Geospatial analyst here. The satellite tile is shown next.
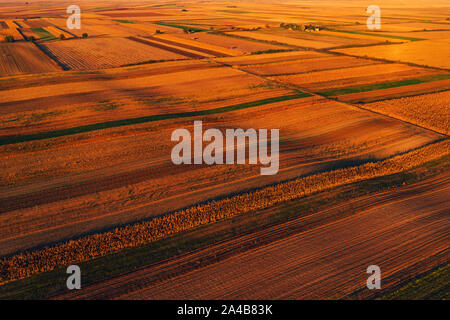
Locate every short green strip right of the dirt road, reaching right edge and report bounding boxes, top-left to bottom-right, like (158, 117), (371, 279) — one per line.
(318, 74), (450, 97)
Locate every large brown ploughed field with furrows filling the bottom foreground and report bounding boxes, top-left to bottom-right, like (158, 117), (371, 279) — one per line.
(57, 174), (450, 300)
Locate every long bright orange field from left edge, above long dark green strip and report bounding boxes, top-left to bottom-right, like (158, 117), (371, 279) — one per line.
(0, 64), (268, 113)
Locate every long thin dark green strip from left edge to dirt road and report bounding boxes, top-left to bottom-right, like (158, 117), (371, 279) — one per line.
(0, 93), (311, 146)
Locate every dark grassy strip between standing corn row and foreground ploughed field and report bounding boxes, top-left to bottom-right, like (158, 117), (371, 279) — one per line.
(0, 156), (450, 299)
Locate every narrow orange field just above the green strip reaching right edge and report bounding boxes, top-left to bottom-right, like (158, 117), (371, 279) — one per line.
(242, 56), (377, 76)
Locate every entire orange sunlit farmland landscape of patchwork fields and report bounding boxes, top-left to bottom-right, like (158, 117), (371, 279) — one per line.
(0, 0), (450, 300)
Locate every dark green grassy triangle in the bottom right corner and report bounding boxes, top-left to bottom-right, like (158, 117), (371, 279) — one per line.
(380, 264), (450, 300)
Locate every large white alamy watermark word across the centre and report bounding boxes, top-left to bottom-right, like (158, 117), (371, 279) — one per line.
(171, 121), (280, 175)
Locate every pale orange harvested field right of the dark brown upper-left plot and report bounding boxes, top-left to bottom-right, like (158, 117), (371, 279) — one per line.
(42, 38), (184, 70)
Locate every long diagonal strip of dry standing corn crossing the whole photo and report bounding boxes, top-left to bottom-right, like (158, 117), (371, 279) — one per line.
(0, 140), (450, 283)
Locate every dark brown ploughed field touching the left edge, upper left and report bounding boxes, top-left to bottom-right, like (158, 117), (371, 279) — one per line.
(0, 43), (61, 77)
